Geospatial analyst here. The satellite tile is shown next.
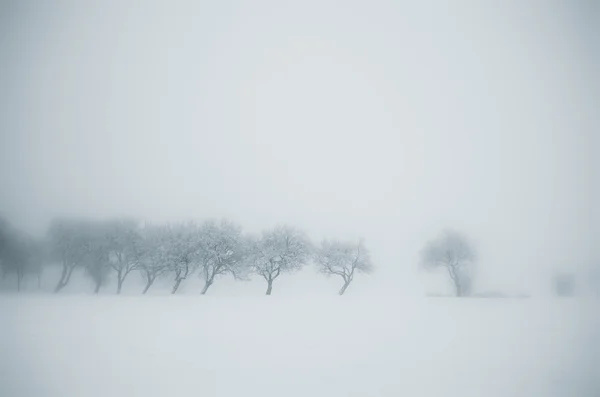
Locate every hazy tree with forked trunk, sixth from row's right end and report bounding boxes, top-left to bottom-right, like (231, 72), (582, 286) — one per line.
(107, 218), (141, 294)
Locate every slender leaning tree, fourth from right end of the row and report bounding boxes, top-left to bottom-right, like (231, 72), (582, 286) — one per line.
(167, 222), (201, 294)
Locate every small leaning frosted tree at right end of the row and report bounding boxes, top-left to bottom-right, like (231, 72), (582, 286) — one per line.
(315, 239), (373, 295)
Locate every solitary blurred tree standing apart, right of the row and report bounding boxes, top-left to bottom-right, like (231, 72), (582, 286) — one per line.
(421, 230), (476, 297)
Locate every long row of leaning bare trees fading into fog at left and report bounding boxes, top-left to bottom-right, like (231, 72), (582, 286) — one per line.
(0, 218), (373, 295)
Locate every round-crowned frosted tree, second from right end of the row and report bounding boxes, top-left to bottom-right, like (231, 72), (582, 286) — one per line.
(249, 226), (312, 295)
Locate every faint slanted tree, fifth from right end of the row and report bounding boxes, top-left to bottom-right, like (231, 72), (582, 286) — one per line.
(137, 225), (169, 294)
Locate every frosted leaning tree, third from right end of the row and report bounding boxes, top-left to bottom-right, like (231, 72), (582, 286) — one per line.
(198, 220), (248, 295)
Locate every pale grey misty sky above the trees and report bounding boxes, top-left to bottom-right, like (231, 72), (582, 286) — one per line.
(0, 0), (600, 290)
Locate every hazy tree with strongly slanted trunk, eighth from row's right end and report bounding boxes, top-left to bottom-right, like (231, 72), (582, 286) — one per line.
(48, 218), (87, 293)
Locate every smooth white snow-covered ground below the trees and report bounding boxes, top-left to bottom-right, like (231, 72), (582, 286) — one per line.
(0, 295), (600, 397)
